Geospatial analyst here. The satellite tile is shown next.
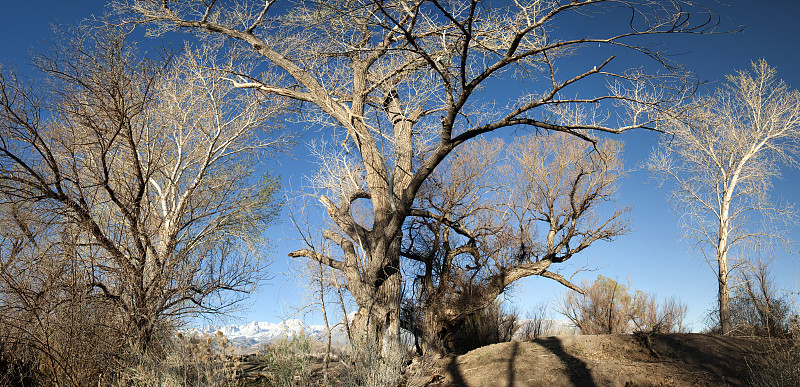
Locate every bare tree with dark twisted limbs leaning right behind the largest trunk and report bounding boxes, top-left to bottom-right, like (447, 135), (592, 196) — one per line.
(401, 133), (628, 350)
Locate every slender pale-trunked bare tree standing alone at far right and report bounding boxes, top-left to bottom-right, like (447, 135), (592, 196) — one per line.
(648, 60), (800, 334)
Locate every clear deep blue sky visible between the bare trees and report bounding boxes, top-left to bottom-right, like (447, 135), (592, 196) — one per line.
(0, 0), (800, 329)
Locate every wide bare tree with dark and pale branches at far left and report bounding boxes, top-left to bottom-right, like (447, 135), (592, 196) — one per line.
(0, 28), (287, 350)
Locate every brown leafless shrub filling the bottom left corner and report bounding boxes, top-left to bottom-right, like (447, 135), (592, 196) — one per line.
(0, 292), (124, 386)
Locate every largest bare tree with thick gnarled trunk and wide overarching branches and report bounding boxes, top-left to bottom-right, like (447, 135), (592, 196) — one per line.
(114, 0), (715, 354)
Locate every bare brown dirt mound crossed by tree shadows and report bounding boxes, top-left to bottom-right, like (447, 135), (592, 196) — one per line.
(424, 333), (765, 387)
